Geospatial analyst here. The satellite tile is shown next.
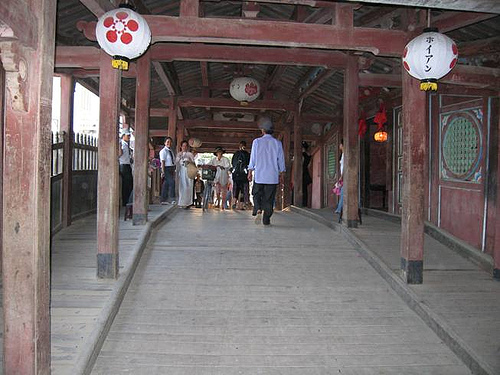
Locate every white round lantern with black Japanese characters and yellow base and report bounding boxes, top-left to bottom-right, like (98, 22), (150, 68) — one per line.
(403, 28), (458, 91)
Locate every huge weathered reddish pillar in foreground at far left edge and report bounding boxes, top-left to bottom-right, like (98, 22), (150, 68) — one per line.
(0, 0), (56, 375)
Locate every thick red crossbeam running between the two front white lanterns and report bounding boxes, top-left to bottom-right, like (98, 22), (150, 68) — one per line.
(77, 15), (408, 56)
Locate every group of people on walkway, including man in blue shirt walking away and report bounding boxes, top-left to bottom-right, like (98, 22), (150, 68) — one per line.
(160, 117), (285, 225)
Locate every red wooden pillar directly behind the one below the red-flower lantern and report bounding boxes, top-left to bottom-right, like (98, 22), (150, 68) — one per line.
(132, 52), (151, 225)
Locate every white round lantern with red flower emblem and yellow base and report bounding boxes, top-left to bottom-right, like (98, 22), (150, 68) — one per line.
(96, 7), (151, 70)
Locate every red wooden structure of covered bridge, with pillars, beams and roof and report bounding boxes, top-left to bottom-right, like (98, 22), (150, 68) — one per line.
(0, 0), (500, 374)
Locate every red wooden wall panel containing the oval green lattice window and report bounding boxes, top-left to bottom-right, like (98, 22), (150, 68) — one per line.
(429, 95), (489, 249)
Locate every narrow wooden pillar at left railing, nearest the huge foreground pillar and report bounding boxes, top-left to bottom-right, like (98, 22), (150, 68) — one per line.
(61, 75), (75, 227)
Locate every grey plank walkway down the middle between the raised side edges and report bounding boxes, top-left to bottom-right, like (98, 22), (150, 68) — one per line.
(93, 209), (470, 375)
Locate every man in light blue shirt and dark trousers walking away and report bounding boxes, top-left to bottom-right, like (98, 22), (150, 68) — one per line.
(248, 117), (285, 225)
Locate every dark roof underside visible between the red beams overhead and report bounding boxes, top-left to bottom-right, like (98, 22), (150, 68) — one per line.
(56, 0), (500, 151)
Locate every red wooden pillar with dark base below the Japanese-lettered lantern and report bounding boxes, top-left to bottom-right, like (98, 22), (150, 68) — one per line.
(401, 71), (429, 284)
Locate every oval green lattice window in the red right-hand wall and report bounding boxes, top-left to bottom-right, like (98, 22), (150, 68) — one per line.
(441, 114), (481, 180)
